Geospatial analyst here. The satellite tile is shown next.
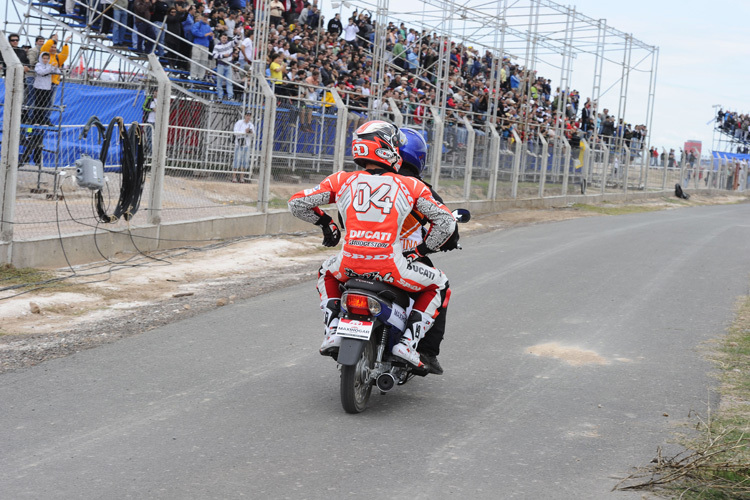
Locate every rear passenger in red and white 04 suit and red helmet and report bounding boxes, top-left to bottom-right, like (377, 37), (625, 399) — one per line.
(289, 120), (456, 368)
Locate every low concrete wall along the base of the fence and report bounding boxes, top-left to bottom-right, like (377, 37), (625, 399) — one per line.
(0, 191), (716, 269)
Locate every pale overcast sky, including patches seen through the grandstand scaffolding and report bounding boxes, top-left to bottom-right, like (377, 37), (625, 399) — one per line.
(323, 0), (750, 154)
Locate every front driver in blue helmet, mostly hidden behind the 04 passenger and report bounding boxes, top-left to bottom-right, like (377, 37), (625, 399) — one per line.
(398, 128), (458, 375)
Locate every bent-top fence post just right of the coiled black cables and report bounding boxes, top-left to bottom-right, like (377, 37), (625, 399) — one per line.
(148, 53), (172, 225)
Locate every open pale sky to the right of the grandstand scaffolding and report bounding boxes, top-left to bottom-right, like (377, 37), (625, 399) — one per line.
(571, 0), (750, 154)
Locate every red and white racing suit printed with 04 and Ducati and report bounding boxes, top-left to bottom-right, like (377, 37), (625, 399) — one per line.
(289, 169), (456, 318)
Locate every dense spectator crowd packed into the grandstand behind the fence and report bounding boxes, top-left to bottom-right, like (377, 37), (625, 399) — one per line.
(2, 0), (652, 158)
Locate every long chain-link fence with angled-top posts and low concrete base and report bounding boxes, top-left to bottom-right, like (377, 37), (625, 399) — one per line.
(0, 39), (748, 262)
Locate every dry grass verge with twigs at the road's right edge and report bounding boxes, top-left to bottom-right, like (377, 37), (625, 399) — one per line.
(617, 297), (750, 500)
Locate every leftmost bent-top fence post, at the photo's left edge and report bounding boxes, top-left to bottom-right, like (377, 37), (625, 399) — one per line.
(0, 34), (23, 249)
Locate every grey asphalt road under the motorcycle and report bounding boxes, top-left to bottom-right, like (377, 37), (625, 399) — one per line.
(0, 204), (750, 499)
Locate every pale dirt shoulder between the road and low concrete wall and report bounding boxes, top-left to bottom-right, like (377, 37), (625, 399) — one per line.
(0, 191), (748, 373)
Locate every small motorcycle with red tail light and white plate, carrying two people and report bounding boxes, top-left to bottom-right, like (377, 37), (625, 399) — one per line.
(335, 209), (471, 414)
